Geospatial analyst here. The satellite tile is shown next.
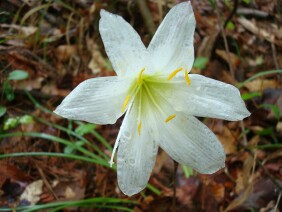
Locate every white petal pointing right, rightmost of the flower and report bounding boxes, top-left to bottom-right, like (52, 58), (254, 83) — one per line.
(151, 74), (250, 121)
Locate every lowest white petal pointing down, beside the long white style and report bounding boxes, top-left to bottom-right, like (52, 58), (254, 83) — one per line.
(117, 93), (158, 196)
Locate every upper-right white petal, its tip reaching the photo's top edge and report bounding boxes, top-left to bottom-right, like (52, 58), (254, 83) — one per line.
(148, 2), (196, 73)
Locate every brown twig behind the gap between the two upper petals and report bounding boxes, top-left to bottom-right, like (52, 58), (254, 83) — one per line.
(136, 0), (156, 36)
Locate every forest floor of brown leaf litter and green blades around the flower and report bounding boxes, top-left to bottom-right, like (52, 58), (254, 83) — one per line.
(0, 0), (282, 212)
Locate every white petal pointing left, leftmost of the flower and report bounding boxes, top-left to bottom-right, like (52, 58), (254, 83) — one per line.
(54, 77), (131, 124)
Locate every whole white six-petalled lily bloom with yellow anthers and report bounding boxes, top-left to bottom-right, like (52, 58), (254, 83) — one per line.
(55, 2), (250, 195)
